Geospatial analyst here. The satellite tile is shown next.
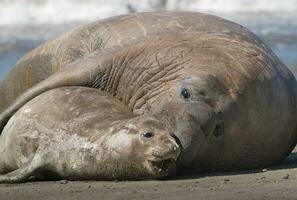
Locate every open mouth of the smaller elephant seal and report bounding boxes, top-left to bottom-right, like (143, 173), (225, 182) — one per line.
(148, 158), (176, 176)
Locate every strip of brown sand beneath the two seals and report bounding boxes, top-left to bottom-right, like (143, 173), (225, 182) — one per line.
(0, 149), (297, 200)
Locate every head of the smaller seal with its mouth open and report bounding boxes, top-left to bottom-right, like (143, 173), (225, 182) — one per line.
(104, 116), (180, 180)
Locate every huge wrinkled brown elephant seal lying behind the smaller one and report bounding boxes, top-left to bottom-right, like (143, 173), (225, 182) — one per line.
(0, 12), (297, 172)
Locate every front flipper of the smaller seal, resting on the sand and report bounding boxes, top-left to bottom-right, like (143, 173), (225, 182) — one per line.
(0, 154), (45, 183)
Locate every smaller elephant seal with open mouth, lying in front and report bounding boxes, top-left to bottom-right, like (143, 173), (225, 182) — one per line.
(0, 87), (180, 183)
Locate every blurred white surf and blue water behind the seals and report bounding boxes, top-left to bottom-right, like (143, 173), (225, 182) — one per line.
(0, 0), (297, 80)
